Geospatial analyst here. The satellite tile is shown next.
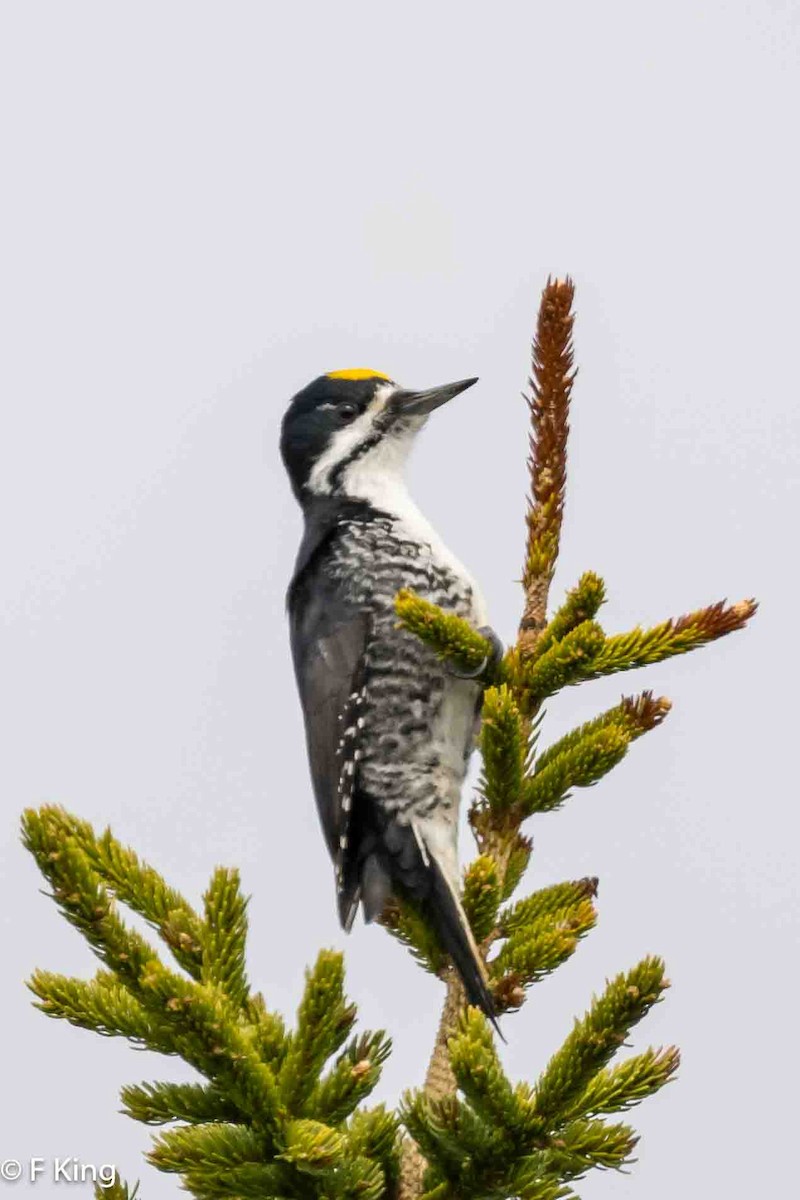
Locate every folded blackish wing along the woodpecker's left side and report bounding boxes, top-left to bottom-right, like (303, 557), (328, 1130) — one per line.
(289, 556), (368, 863)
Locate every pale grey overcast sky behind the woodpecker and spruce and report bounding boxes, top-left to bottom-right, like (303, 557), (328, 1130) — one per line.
(0, 0), (800, 1200)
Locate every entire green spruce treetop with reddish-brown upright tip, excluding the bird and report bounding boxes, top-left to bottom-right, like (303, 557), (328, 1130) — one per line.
(23, 280), (756, 1200)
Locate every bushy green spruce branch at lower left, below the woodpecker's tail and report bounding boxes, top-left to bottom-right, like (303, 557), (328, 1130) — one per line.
(24, 809), (399, 1200)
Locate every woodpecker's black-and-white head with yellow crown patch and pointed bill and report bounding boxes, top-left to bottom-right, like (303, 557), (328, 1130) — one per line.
(281, 367), (477, 503)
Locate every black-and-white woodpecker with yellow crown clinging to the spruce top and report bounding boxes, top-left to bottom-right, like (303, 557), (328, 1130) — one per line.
(281, 368), (495, 1019)
